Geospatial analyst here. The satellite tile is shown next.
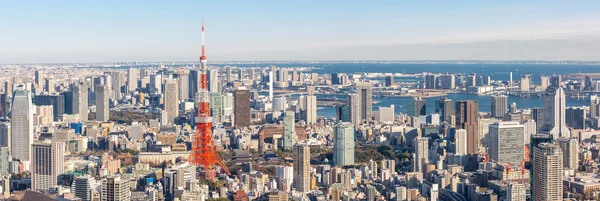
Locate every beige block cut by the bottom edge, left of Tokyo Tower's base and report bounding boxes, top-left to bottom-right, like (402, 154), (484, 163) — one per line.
(101, 177), (131, 201)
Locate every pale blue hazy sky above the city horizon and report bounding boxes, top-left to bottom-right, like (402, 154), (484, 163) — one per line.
(0, 0), (600, 63)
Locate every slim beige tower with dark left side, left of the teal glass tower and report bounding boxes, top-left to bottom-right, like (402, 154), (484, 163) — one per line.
(293, 144), (310, 193)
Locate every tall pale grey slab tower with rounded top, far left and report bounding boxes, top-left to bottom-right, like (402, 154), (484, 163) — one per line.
(10, 89), (34, 161)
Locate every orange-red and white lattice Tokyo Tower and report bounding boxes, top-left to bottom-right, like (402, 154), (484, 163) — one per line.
(188, 20), (231, 180)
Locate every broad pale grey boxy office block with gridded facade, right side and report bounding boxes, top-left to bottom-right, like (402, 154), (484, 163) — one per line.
(488, 121), (525, 166)
